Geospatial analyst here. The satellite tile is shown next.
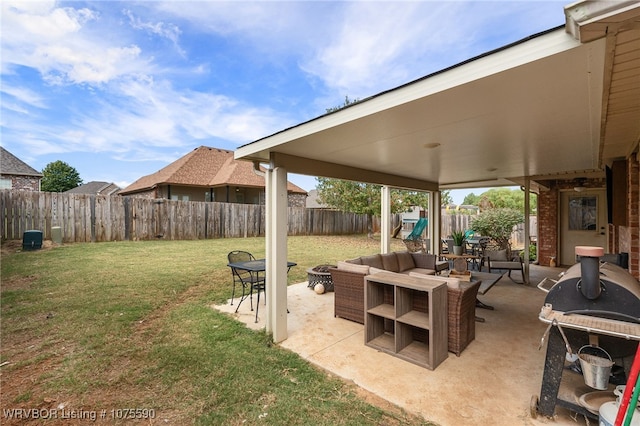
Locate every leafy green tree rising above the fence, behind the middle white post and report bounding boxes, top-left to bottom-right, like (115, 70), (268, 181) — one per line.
(316, 178), (429, 237)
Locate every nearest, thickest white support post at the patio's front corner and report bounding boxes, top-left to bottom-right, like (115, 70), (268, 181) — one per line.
(265, 167), (288, 343)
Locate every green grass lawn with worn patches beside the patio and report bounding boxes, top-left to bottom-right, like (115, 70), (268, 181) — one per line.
(0, 236), (426, 425)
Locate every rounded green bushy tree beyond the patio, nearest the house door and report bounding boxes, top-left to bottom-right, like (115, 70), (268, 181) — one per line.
(470, 208), (524, 256)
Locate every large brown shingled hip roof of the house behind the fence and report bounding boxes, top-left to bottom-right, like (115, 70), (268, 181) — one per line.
(120, 146), (307, 195)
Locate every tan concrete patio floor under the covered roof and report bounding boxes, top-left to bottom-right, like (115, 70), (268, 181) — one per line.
(215, 265), (597, 425)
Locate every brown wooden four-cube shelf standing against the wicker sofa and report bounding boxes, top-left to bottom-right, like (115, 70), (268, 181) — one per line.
(365, 272), (448, 370)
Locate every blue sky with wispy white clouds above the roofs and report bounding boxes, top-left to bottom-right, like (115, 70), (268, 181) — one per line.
(0, 0), (570, 203)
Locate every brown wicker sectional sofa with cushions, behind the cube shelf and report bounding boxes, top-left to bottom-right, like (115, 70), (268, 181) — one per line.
(329, 252), (480, 356)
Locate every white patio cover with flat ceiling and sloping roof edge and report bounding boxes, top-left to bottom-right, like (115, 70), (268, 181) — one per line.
(235, 2), (640, 190)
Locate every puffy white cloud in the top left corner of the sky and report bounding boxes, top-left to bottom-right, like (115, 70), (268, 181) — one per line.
(2, 2), (148, 84)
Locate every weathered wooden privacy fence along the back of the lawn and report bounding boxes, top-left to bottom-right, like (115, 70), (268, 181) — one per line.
(0, 190), (382, 242)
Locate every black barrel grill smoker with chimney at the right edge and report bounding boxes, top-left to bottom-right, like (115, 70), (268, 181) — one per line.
(531, 247), (640, 419)
